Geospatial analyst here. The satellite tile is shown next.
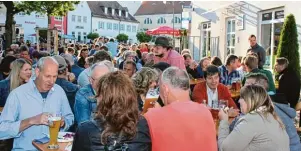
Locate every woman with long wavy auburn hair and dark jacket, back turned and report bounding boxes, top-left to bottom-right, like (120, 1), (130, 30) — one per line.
(72, 71), (151, 151)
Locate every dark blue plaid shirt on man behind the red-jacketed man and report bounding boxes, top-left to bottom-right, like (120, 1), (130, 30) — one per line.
(218, 65), (241, 85)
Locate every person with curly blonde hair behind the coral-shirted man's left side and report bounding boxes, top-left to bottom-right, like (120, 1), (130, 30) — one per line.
(132, 67), (159, 111)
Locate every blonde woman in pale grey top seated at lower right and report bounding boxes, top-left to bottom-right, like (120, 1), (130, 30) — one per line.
(218, 85), (289, 151)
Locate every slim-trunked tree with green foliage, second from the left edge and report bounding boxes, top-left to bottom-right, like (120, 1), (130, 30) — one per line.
(20, 1), (79, 51)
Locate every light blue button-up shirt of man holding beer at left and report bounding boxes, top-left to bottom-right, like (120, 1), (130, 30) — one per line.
(0, 80), (74, 151)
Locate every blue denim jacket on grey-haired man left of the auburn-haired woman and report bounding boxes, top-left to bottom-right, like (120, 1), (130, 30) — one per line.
(74, 84), (97, 125)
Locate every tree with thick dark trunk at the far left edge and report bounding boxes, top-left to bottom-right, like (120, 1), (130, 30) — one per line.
(0, 1), (31, 48)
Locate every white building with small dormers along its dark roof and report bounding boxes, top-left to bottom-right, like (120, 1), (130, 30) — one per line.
(87, 1), (139, 43)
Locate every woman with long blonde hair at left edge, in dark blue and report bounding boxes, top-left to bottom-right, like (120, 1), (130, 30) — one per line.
(0, 59), (32, 107)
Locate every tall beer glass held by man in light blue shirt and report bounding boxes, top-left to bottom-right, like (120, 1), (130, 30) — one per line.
(48, 113), (62, 149)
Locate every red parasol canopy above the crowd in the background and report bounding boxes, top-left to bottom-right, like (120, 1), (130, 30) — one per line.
(146, 26), (180, 36)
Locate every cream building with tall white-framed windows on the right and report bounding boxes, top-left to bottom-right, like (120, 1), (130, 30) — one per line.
(190, 1), (301, 67)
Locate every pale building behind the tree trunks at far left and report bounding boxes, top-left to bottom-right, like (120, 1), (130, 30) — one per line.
(0, 4), (48, 43)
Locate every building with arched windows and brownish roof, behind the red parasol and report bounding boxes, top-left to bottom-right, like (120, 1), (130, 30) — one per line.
(134, 1), (190, 31)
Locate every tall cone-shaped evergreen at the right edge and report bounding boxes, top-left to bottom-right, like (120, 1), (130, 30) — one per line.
(277, 14), (300, 75)
